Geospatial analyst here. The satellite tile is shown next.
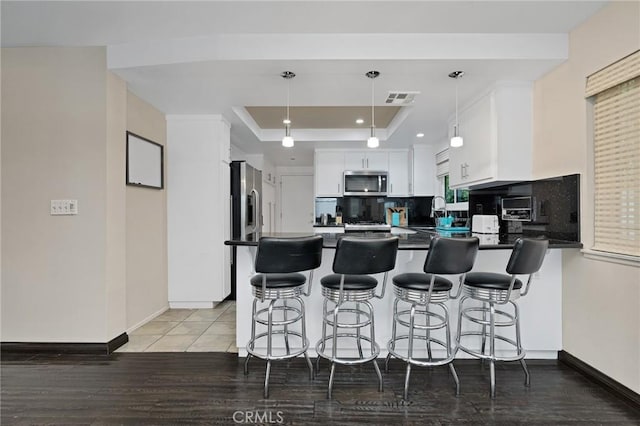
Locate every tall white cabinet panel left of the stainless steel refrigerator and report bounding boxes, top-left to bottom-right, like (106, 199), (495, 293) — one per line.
(167, 115), (231, 308)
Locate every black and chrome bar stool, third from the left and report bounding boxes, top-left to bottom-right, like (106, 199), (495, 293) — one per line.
(385, 237), (479, 400)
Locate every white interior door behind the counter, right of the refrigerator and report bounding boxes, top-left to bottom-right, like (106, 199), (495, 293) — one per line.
(279, 175), (315, 232)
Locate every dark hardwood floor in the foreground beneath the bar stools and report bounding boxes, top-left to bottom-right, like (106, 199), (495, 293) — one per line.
(1, 353), (640, 426)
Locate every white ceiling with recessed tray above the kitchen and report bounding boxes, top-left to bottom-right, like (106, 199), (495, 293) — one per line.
(1, 0), (606, 166)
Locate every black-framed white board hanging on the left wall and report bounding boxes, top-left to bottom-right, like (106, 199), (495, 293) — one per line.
(126, 132), (164, 189)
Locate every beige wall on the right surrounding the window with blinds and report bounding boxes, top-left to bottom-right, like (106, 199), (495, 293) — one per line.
(533, 2), (640, 392)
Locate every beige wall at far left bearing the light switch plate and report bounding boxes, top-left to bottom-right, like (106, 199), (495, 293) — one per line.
(1, 48), (125, 342)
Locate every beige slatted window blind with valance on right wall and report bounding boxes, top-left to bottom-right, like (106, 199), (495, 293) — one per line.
(587, 62), (640, 256)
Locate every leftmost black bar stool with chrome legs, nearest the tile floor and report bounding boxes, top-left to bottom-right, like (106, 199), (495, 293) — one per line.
(244, 235), (322, 398)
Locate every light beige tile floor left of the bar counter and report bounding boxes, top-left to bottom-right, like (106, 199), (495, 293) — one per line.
(116, 301), (238, 352)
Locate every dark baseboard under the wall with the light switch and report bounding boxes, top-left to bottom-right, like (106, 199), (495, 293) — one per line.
(0, 333), (129, 355)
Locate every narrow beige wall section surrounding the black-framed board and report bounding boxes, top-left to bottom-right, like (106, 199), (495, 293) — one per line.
(126, 92), (169, 330)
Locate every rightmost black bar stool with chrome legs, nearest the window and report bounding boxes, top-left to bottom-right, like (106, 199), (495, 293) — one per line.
(456, 238), (549, 398)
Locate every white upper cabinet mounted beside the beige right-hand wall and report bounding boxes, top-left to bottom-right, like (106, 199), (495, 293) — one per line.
(449, 82), (532, 188)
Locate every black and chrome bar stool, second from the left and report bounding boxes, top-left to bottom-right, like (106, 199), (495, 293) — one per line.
(316, 237), (398, 398)
